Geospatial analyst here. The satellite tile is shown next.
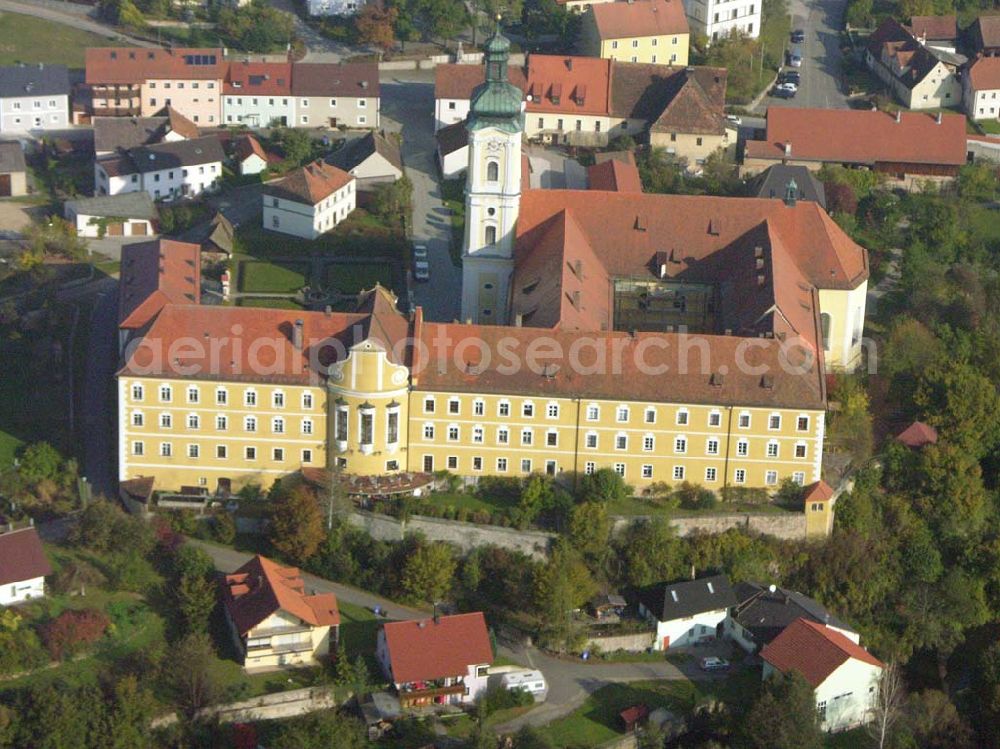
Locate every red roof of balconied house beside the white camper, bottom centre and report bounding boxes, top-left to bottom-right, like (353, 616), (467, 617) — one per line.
(383, 611), (493, 684)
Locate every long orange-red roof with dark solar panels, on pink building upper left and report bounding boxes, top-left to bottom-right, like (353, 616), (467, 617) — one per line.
(85, 47), (226, 85)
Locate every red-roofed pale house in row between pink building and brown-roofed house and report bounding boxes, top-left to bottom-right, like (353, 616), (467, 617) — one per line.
(222, 62), (295, 128)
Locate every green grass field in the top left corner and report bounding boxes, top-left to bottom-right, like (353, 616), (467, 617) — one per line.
(0, 13), (128, 68)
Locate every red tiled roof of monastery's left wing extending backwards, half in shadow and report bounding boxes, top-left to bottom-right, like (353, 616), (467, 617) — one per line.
(118, 239), (201, 329)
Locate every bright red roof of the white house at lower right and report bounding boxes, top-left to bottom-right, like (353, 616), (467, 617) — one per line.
(760, 619), (885, 689)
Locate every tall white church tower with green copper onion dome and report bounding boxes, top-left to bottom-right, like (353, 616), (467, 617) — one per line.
(462, 26), (524, 325)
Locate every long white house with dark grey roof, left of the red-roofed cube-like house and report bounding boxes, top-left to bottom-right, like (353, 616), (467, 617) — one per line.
(94, 136), (225, 200)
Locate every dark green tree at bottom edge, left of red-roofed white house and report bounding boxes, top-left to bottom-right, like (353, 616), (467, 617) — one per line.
(741, 671), (823, 749)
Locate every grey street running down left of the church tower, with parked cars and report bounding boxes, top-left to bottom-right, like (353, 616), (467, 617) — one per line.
(382, 71), (462, 322)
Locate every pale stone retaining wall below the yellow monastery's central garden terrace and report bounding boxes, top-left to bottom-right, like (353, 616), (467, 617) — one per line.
(349, 511), (556, 559)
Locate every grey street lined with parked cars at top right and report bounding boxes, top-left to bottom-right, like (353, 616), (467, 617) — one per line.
(761, 0), (847, 109)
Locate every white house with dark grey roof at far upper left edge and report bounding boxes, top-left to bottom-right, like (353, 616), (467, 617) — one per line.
(0, 63), (70, 134)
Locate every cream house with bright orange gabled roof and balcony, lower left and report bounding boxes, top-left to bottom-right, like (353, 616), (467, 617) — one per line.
(222, 554), (340, 672)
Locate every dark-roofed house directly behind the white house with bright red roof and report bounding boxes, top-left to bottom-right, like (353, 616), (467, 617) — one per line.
(725, 583), (861, 654)
